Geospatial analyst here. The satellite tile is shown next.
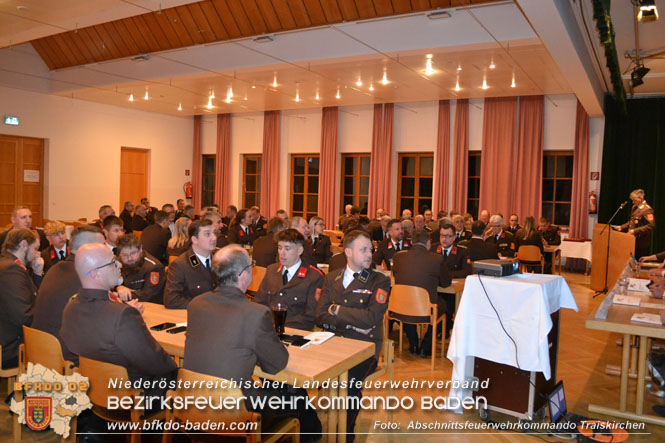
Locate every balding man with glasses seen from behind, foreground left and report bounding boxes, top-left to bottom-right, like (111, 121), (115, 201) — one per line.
(60, 243), (177, 378)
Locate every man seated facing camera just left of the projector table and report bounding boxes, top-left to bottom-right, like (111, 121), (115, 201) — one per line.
(432, 223), (471, 338)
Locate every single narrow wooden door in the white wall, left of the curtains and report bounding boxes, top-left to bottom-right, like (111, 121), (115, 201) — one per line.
(118, 148), (150, 214)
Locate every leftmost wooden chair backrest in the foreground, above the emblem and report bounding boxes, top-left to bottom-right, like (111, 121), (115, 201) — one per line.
(19, 326), (74, 375)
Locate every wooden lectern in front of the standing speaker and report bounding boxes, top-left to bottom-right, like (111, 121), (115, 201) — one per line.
(591, 223), (635, 291)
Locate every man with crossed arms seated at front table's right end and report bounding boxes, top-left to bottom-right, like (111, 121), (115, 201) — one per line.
(316, 231), (390, 442)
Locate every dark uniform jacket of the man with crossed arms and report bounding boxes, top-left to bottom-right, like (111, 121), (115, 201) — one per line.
(316, 269), (390, 359)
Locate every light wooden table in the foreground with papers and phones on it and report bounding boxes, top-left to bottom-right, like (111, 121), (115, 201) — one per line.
(143, 303), (374, 442)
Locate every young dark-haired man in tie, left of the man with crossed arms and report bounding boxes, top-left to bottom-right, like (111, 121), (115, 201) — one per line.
(255, 229), (323, 331)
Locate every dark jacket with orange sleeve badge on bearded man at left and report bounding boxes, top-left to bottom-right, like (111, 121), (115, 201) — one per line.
(121, 253), (166, 304)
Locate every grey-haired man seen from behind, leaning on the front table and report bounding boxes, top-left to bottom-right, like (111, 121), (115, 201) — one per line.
(184, 245), (321, 440)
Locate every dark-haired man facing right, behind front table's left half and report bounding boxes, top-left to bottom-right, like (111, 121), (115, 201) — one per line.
(164, 220), (217, 309)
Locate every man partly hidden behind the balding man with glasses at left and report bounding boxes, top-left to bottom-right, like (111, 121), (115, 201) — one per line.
(32, 227), (105, 362)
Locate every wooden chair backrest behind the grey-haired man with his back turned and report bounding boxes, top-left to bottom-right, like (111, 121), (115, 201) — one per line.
(169, 369), (260, 428)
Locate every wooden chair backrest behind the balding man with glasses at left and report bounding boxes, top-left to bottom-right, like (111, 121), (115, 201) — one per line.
(78, 357), (139, 409)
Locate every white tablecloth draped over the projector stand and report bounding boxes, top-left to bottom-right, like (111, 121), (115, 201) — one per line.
(448, 274), (577, 412)
